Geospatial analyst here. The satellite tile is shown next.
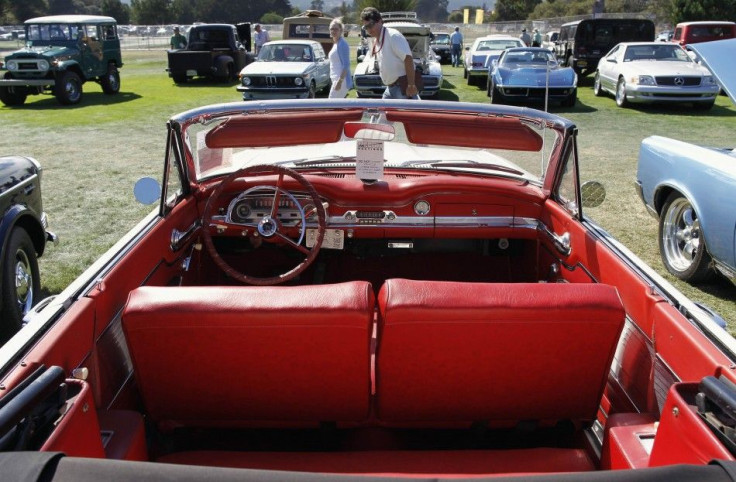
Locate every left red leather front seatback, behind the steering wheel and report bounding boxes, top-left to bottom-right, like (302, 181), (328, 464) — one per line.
(122, 282), (375, 426)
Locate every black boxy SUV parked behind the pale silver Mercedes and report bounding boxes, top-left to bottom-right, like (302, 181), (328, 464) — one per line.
(555, 18), (654, 75)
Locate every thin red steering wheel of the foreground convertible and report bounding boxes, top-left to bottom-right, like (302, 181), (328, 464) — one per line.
(202, 165), (326, 286)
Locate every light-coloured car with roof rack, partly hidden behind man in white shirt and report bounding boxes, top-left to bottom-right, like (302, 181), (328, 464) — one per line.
(353, 12), (442, 98)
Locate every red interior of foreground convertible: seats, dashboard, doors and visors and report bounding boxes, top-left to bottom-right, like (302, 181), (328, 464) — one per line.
(0, 103), (736, 480)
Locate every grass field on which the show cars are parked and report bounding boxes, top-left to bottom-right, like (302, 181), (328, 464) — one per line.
(0, 45), (736, 333)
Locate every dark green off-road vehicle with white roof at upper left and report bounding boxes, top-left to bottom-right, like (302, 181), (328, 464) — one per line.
(0, 15), (123, 106)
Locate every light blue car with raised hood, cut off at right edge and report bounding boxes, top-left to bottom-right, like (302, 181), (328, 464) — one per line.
(636, 39), (736, 283)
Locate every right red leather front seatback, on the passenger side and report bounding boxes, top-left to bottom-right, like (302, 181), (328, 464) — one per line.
(376, 279), (624, 423)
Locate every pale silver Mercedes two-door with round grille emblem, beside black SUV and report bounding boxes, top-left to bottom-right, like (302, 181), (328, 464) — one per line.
(593, 42), (719, 110)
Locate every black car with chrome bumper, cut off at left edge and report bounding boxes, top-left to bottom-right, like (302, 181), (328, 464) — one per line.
(0, 156), (56, 345)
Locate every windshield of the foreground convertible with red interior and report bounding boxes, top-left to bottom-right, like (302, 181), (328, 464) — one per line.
(184, 104), (560, 185)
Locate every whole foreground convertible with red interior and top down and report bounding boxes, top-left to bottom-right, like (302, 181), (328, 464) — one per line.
(0, 99), (736, 481)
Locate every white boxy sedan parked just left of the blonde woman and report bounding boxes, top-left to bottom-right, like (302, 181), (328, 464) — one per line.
(237, 40), (330, 100)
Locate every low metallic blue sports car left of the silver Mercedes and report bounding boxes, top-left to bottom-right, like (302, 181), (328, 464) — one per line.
(488, 47), (578, 107)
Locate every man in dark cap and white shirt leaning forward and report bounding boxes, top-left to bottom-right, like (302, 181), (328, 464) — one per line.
(360, 7), (419, 99)
